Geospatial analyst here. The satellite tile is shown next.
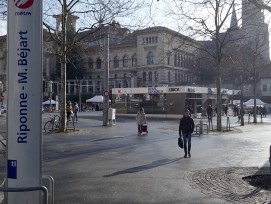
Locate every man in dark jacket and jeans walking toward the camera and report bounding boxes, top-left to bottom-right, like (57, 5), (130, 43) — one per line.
(179, 110), (195, 158)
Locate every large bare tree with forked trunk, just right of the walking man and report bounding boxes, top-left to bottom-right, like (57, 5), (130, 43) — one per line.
(167, 0), (241, 131)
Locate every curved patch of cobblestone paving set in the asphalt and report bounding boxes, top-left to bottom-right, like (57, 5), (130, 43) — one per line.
(184, 167), (271, 204)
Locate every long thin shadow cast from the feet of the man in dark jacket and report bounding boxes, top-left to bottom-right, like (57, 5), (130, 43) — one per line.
(103, 158), (182, 177)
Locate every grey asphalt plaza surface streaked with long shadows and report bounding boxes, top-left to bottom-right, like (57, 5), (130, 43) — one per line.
(0, 112), (271, 204)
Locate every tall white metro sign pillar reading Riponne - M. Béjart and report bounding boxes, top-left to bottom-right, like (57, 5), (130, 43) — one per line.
(7, 0), (42, 204)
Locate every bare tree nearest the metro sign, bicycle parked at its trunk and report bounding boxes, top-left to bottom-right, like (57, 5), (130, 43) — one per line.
(44, 0), (147, 132)
